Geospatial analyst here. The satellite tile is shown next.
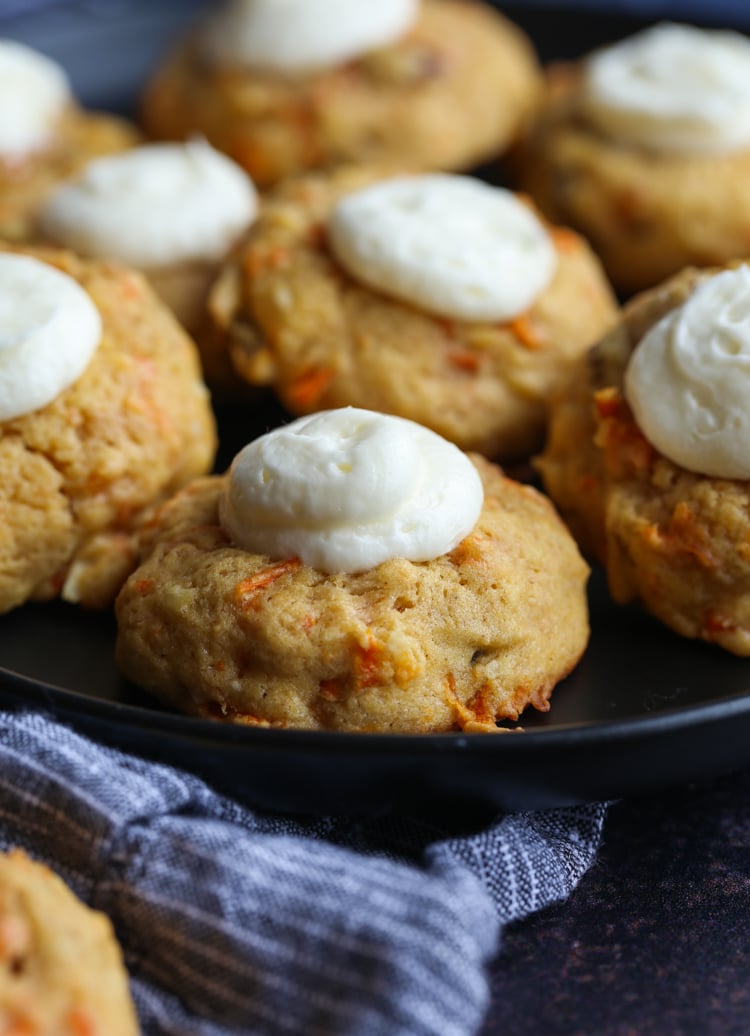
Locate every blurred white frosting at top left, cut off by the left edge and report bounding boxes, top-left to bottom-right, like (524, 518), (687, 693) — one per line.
(0, 39), (71, 156)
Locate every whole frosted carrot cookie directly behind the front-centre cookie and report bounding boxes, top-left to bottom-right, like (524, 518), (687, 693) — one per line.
(207, 168), (616, 459)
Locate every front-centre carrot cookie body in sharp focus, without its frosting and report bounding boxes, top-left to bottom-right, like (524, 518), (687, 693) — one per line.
(116, 456), (588, 732)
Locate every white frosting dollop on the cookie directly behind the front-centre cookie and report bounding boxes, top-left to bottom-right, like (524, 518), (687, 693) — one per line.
(327, 173), (557, 321)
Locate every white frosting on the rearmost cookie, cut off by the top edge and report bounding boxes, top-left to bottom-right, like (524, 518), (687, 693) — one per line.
(200, 0), (420, 75)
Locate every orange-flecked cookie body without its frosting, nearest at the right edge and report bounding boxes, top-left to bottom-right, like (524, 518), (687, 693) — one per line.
(538, 269), (750, 656)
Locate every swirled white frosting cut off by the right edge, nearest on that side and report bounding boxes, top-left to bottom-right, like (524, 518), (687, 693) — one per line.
(625, 265), (750, 479)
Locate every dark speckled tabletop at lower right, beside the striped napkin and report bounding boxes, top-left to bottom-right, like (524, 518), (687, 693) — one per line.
(482, 772), (750, 1036)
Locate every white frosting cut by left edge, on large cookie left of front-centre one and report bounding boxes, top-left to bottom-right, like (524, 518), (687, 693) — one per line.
(0, 254), (102, 421)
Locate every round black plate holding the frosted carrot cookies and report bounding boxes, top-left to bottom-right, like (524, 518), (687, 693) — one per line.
(0, 0), (750, 812)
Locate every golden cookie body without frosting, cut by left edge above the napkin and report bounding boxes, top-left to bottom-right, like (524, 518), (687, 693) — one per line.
(0, 246), (215, 611)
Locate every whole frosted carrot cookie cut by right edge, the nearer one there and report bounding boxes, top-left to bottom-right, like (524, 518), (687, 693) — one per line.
(539, 264), (750, 655)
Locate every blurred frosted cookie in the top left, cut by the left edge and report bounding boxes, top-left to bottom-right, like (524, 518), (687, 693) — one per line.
(0, 39), (141, 241)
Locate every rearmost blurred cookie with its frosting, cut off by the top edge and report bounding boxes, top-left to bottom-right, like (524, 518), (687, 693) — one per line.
(137, 0), (542, 186)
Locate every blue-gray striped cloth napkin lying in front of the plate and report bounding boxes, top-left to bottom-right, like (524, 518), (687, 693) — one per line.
(0, 712), (606, 1036)
